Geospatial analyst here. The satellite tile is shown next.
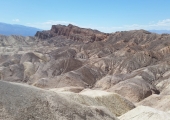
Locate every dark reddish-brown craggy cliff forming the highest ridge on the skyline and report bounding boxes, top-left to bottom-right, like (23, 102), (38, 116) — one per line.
(35, 24), (109, 42)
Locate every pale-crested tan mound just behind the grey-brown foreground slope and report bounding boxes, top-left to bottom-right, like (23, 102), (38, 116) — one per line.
(52, 89), (135, 116)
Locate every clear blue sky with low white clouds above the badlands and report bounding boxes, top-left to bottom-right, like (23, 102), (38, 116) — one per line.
(0, 0), (170, 32)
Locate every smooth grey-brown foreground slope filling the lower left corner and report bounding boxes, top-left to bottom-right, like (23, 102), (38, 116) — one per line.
(0, 81), (118, 120)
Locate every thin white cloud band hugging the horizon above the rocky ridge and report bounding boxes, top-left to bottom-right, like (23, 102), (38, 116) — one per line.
(26, 19), (170, 32)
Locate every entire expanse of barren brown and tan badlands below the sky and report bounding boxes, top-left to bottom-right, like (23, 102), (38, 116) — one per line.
(0, 24), (170, 120)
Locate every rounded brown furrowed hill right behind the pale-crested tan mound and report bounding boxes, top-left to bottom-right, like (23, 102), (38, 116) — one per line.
(108, 76), (158, 102)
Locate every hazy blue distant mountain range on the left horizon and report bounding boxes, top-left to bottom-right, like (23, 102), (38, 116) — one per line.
(0, 22), (41, 36)
